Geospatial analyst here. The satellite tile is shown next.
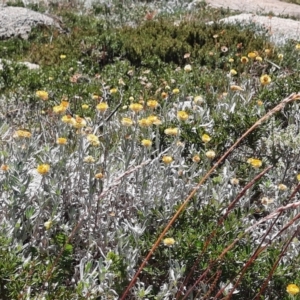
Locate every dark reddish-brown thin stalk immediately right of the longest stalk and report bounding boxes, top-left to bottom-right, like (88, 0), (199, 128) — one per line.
(176, 166), (272, 300)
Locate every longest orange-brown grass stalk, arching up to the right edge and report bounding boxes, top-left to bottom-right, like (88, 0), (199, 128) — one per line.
(120, 93), (300, 300)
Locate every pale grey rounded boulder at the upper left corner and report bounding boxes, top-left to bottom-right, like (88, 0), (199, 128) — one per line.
(0, 6), (63, 39)
